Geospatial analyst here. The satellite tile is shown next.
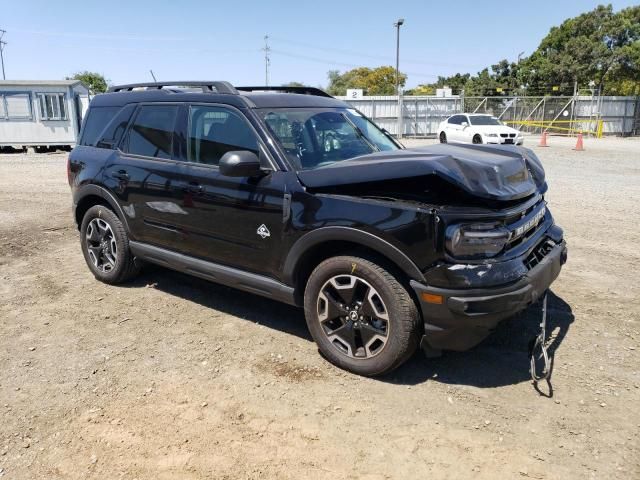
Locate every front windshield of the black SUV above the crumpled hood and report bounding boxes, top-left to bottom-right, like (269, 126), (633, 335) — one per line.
(260, 108), (400, 170)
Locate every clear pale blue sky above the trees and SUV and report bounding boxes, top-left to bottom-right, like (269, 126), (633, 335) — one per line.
(0, 0), (636, 88)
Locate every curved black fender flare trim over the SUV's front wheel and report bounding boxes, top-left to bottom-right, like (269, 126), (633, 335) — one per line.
(282, 226), (424, 285)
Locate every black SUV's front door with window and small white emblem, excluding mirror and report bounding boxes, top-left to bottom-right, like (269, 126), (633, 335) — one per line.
(175, 104), (286, 276)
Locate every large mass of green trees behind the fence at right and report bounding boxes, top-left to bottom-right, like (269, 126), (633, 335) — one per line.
(411, 5), (640, 96)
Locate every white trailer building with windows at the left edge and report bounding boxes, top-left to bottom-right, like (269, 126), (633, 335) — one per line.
(0, 80), (90, 149)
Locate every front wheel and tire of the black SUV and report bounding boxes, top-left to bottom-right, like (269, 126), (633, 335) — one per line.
(304, 256), (420, 377)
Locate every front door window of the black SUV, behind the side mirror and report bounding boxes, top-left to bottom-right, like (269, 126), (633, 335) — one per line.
(188, 106), (258, 165)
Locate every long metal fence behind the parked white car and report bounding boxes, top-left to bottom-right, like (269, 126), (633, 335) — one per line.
(342, 96), (640, 137)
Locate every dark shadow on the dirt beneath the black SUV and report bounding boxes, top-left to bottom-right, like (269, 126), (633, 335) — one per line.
(126, 266), (574, 390)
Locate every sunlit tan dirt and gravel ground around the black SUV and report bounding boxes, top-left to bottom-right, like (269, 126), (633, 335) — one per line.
(0, 137), (640, 480)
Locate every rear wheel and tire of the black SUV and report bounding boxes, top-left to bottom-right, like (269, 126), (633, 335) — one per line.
(80, 205), (140, 285)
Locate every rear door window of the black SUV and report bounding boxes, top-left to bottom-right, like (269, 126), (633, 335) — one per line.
(124, 105), (178, 158)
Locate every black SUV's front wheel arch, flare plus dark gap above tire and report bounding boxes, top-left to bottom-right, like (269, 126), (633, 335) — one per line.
(283, 227), (424, 300)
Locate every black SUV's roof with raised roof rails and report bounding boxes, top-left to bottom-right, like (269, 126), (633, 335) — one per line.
(91, 81), (349, 108)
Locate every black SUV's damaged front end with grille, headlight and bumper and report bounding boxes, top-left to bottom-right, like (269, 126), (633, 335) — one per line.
(418, 194), (567, 350)
